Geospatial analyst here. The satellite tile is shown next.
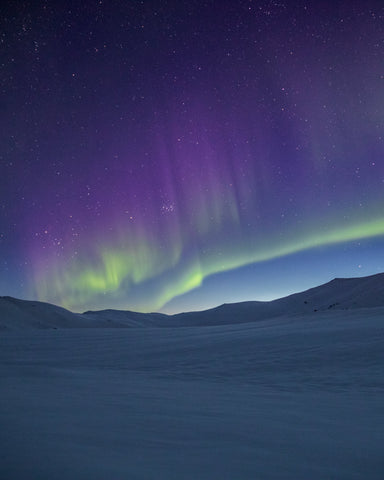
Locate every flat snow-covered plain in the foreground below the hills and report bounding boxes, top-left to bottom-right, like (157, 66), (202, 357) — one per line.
(0, 310), (384, 480)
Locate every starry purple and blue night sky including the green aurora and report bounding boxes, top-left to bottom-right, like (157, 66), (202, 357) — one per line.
(0, 0), (384, 313)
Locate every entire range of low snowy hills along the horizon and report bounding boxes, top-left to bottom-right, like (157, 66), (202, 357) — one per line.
(0, 273), (384, 329)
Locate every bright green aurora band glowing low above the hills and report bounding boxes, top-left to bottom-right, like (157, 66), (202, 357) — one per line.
(33, 219), (384, 311)
